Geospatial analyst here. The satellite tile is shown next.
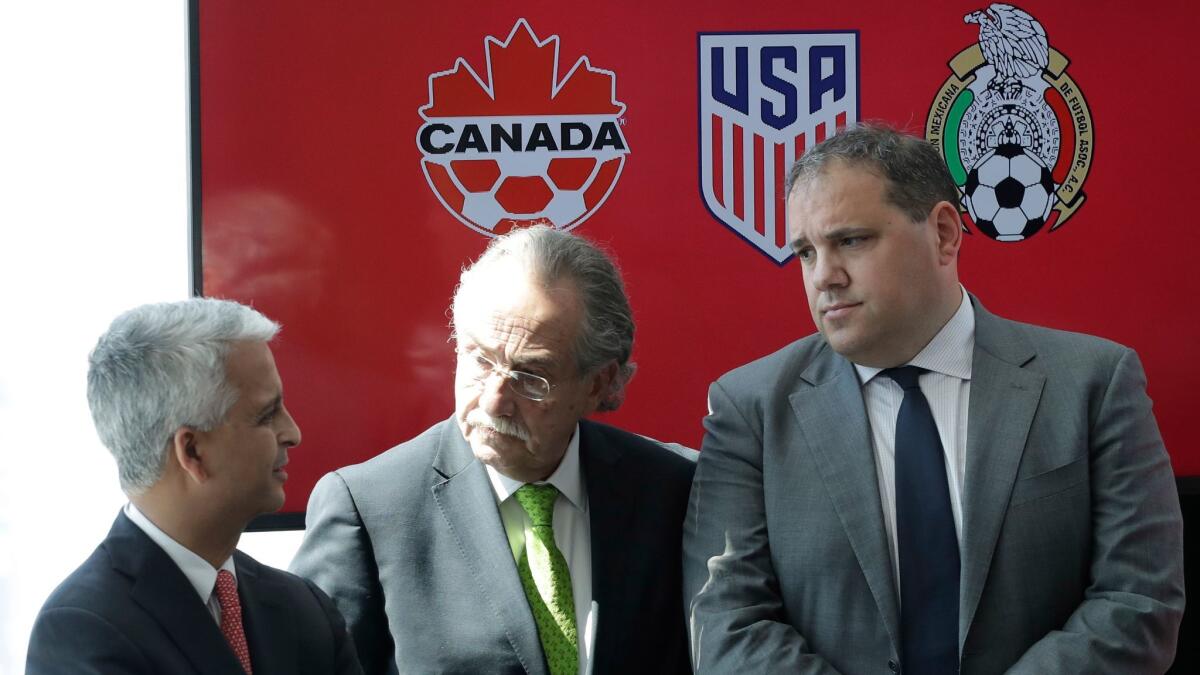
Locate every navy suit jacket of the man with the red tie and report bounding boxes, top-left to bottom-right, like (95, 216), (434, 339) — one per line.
(25, 513), (362, 675)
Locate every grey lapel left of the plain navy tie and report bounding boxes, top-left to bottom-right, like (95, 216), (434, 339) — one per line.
(788, 346), (900, 645)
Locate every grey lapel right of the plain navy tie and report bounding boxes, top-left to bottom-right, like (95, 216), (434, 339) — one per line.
(959, 302), (1045, 645)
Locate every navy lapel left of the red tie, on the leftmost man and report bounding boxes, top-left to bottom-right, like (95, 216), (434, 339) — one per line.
(106, 513), (241, 673)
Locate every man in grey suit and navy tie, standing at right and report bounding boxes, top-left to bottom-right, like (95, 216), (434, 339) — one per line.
(684, 126), (1183, 675)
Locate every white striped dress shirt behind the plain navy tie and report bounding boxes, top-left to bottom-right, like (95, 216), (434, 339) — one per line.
(854, 286), (974, 592)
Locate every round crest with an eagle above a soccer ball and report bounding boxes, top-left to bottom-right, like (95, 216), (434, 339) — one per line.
(925, 4), (1094, 241)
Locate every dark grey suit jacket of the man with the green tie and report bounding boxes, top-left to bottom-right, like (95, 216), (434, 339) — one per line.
(292, 418), (695, 675)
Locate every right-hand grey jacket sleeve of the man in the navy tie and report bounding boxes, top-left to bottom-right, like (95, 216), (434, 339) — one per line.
(1010, 350), (1184, 674)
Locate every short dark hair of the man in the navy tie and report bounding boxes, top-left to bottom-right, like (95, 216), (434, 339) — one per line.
(785, 124), (959, 221)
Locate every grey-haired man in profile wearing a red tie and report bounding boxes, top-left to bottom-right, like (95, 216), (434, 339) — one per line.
(26, 298), (361, 675)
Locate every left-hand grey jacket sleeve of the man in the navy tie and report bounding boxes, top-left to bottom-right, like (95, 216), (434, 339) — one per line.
(683, 382), (836, 675)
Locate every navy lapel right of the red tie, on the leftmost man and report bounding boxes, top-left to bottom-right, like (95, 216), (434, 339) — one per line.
(234, 551), (300, 673)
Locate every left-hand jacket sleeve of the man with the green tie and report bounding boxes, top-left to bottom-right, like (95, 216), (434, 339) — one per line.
(290, 472), (396, 673)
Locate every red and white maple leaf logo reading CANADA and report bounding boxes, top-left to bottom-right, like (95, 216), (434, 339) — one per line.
(416, 19), (629, 237)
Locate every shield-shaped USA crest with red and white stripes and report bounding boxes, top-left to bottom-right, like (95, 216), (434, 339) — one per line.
(697, 31), (858, 264)
